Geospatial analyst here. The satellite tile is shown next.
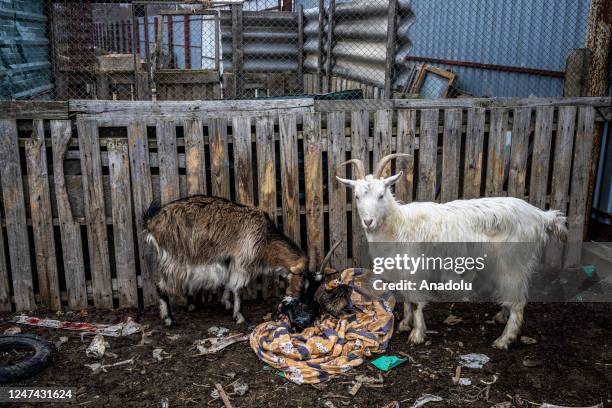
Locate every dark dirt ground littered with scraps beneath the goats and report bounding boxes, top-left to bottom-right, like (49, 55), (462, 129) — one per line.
(0, 301), (612, 408)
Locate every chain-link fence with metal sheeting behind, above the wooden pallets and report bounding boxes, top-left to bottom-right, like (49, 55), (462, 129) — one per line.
(0, 0), (590, 100)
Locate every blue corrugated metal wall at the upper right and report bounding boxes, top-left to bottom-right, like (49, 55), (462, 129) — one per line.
(409, 0), (590, 96)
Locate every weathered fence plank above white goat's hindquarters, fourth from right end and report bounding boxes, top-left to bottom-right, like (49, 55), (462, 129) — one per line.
(508, 108), (531, 198)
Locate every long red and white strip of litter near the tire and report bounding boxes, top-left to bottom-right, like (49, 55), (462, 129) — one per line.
(15, 315), (142, 337)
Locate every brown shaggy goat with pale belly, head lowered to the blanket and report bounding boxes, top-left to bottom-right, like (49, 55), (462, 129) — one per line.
(144, 195), (308, 326)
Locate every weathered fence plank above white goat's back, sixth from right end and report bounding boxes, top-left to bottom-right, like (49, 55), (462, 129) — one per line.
(463, 108), (485, 198)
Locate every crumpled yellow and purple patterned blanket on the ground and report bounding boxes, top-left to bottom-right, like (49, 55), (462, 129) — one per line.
(250, 268), (395, 384)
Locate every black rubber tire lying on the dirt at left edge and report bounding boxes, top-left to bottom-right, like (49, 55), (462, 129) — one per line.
(0, 334), (53, 384)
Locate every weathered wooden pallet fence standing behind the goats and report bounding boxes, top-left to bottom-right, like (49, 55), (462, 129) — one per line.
(0, 98), (610, 311)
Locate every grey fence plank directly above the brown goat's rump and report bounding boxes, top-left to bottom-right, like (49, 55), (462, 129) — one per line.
(155, 121), (181, 204)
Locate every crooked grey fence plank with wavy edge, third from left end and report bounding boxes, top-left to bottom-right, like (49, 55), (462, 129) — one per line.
(51, 120), (87, 309)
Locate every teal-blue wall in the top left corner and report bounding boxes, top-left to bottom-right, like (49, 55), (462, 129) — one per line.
(0, 0), (53, 99)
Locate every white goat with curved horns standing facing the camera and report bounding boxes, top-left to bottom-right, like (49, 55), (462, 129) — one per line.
(336, 153), (567, 349)
